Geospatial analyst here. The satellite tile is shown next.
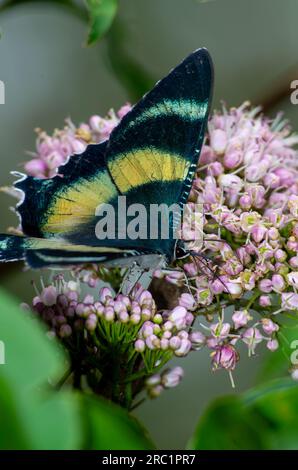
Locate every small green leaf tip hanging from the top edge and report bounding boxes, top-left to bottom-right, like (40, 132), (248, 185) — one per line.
(86, 0), (118, 46)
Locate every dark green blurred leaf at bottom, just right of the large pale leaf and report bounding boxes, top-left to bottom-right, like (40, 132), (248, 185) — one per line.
(81, 396), (154, 450)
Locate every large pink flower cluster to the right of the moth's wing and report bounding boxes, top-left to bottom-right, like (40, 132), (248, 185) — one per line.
(163, 103), (298, 370)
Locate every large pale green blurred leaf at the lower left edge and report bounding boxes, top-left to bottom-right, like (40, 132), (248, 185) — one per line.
(0, 291), (82, 449)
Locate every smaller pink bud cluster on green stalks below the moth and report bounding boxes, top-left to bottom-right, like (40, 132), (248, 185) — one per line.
(23, 275), (197, 398)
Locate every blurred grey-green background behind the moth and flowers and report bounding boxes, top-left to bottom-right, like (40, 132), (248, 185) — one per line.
(0, 0), (298, 449)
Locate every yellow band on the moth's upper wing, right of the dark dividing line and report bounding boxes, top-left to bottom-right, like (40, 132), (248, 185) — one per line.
(108, 148), (190, 193)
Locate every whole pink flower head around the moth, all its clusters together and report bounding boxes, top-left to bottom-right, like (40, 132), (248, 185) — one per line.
(19, 103), (298, 397)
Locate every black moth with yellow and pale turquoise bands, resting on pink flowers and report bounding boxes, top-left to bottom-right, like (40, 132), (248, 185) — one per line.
(0, 48), (213, 290)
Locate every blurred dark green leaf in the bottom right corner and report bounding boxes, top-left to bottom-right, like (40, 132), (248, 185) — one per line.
(189, 379), (298, 450)
